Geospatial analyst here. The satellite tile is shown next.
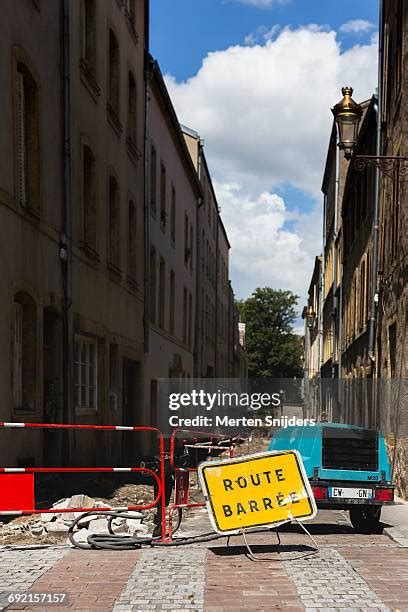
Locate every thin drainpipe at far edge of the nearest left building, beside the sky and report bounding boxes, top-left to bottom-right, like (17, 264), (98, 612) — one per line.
(143, 14), (151, 353)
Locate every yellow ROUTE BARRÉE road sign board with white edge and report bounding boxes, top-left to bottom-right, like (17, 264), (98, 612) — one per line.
(199, 450), (316, 534)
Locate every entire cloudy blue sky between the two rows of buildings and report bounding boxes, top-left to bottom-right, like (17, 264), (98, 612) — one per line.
(151, 0), (378, 314)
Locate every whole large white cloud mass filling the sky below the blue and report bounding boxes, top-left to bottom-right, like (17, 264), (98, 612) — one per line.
(166, 26), (377, 299)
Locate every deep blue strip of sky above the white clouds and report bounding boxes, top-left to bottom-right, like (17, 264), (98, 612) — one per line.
(151, 0), (378, 80)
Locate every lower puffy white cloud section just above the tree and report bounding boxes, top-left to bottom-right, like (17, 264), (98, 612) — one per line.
(215, 182), (321, 305)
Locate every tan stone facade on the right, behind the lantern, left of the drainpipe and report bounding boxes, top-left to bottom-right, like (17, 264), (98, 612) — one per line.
(341, 96), (377, 427)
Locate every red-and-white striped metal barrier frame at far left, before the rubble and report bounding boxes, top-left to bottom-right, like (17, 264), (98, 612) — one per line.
(0, 421), (167, 542)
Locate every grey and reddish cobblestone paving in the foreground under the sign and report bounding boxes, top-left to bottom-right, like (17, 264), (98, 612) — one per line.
(0, 510), (408, 612)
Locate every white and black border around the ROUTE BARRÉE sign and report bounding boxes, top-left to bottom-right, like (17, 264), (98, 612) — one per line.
(198, 449), (317, 535)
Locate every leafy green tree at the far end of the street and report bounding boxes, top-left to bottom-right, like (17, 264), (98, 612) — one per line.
(238, 287), (302, 378)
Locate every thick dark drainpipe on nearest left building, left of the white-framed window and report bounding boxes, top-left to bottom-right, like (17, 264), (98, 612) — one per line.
(59, 0), (72, 463)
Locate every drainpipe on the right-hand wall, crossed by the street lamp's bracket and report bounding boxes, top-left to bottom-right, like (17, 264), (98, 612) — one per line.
(368, 0), (383, 367)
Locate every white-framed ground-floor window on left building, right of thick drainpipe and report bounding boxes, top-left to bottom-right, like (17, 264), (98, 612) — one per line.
(74, 335), (98, 412)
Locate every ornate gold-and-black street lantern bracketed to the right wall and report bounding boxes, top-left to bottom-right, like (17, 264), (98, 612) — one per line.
(331, 87), (363, 159)
